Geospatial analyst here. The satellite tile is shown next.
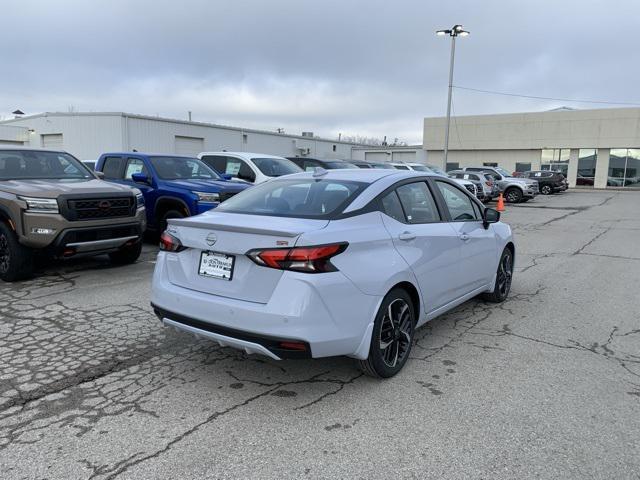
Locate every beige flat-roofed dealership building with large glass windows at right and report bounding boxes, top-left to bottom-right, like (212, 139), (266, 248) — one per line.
(423, 108), (640, 188)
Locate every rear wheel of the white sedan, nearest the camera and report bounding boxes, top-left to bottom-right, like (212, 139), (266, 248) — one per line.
(358, 288), (416, 378)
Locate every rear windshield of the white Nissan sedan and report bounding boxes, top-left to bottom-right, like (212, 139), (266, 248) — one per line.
(216, 178), (367, 218)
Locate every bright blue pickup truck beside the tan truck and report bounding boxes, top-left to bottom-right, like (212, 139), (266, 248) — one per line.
(96, 152), (250, 232)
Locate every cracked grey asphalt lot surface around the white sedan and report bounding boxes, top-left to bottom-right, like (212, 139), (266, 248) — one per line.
(0, 191), (640, 479)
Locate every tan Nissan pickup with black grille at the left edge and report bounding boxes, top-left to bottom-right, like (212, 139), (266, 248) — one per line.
(0, 146), (145, 282)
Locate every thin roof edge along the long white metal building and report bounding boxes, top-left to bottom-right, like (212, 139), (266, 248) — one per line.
(0, 112), (365, 146)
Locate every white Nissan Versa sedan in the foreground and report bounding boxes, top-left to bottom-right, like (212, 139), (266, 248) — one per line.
(152, 168), (515, 377)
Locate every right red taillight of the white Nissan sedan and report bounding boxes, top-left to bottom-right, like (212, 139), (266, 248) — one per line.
(247, 243), (348, 273)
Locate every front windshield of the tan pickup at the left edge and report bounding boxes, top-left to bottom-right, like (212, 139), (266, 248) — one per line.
(0, 150), (94, 180)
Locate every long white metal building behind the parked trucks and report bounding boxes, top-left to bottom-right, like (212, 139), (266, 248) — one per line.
(0, 112), (361, 160)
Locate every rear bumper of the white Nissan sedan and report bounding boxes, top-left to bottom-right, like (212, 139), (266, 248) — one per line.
(151, 252), (382, 358)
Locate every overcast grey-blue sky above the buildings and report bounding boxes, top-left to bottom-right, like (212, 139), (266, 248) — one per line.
(0, 0), (640, 143)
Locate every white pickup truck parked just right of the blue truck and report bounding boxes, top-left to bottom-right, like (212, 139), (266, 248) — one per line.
(198, 152), (302, 184)
